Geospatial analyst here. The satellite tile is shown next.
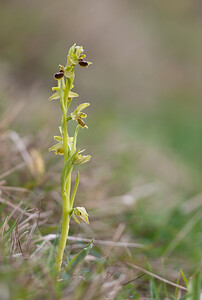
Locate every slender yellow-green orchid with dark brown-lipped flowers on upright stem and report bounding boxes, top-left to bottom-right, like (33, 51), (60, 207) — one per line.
(49, 44), (91, 272)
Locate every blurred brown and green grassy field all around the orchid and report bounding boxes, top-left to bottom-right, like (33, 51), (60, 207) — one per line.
(0, 0), (202, 300)
